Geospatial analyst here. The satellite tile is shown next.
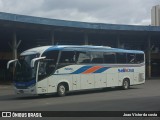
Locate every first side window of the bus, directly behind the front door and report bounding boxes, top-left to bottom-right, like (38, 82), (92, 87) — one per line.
(59, 51), (75, 63)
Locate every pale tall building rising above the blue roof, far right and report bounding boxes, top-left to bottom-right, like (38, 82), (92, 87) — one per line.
(151, 5), (160, 26)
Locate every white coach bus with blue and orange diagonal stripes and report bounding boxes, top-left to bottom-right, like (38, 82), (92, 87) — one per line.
(7, 45), (145, 96)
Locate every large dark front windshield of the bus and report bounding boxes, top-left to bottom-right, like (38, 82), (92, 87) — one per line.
(14, 54), (39, 82)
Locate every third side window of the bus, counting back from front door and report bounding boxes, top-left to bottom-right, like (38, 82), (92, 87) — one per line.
(91, 52), (103, 63)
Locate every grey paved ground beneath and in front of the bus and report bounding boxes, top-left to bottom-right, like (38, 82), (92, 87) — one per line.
(0, 80), (160, 119)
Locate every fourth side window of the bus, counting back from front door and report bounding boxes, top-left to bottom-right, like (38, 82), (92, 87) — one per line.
(104, 52), (116, 63)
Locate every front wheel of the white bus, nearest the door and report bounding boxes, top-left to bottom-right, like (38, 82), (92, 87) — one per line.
(57, 84), (66, 97)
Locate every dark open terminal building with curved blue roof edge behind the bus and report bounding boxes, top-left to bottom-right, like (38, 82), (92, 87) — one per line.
(0, 12), (160, 80)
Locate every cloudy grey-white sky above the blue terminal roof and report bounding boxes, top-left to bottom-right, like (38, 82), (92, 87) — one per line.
(0, 0), (160, 25)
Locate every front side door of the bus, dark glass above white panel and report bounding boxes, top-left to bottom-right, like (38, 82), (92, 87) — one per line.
(37, 50), (59, 93)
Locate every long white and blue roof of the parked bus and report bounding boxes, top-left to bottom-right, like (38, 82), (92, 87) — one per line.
(21, 45), (144, 55)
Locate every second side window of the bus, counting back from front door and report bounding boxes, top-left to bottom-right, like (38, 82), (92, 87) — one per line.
(76, 51), (90, 64)
